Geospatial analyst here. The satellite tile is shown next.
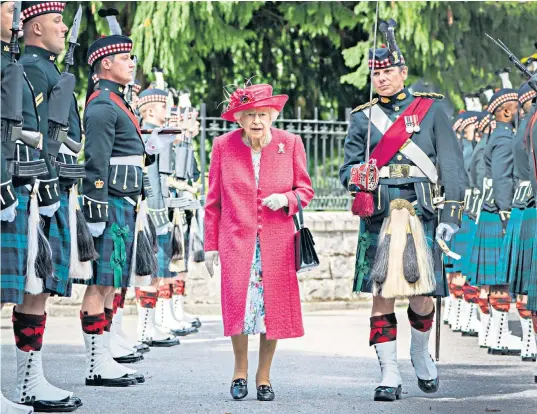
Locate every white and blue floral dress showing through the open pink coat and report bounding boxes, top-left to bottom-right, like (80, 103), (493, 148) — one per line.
(242, 151), (267, 335)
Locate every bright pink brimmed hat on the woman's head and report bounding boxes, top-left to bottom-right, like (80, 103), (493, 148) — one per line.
(222, 84), (289, 122)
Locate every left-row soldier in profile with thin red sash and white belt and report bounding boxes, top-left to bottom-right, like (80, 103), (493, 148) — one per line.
(81, 34), (152, 386)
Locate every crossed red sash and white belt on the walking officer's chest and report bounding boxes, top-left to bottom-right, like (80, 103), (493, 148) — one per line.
(364, 97), (438, 178)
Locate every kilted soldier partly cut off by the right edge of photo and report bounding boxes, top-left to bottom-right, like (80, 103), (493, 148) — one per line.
(500, 83), (537, 361)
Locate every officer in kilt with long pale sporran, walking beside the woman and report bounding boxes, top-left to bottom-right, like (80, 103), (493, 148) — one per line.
(340, 19), (467, 401)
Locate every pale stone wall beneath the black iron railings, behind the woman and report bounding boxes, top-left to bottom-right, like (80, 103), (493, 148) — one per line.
(1, 212), (368, 315)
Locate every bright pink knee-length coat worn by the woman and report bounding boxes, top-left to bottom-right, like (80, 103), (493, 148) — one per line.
(205, 128), (314, 339)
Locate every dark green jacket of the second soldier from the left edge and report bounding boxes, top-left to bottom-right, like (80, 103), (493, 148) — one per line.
(20, 46), (82, 205)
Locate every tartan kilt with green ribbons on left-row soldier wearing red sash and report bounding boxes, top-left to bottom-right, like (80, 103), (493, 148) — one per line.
(76, 195), (136, 288)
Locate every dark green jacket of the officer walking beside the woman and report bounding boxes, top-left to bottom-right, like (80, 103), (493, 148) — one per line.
(339, 88), (468, 225)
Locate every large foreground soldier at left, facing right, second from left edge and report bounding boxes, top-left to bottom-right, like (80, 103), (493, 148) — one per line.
(7, 2), (83, 411)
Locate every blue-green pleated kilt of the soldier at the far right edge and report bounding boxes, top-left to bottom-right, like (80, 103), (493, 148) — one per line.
(501, 207), (537, 295)
